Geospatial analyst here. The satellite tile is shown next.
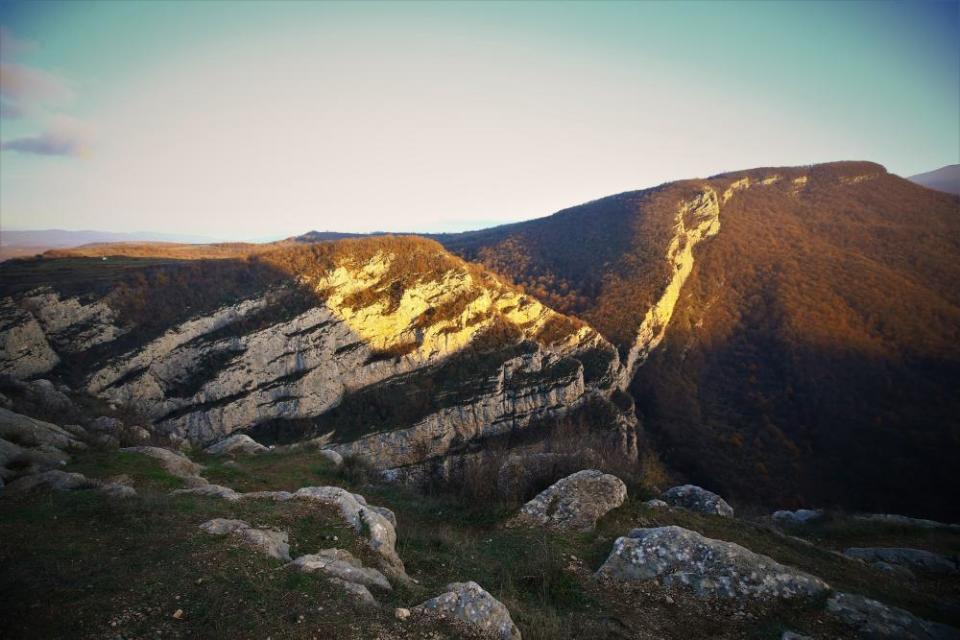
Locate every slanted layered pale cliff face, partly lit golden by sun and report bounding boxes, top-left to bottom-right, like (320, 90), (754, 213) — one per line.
(0, 238), (636, 492)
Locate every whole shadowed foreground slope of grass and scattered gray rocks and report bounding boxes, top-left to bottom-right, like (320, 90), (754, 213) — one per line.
(0, 383), (960, 640)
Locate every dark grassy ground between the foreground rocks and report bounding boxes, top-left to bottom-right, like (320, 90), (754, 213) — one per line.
(0, 452), (956, 640)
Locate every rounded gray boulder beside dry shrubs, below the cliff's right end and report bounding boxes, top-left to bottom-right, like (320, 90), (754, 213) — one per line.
(507, 469), (627, 531)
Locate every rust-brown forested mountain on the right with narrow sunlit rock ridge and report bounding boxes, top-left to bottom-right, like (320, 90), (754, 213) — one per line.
(441, 162), (960, 517)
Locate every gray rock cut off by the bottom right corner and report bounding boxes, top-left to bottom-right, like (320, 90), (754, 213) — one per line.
(827, 593), (960, 640)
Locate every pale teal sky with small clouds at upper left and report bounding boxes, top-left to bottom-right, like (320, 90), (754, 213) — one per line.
(0, 0), (960, 239)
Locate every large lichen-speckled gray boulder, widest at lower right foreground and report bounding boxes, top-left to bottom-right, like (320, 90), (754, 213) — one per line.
(597, 527), (829, 599)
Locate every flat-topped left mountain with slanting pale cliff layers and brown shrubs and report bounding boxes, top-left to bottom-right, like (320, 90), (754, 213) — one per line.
(0, 236), (637, 491)
